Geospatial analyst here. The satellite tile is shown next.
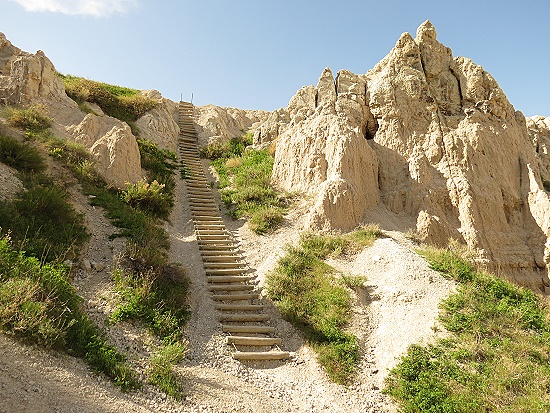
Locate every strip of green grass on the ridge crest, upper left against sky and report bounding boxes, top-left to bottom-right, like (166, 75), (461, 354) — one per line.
(58, 73), (158, 124)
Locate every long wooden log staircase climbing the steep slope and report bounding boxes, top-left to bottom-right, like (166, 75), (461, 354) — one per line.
(178, 102), (289, 360)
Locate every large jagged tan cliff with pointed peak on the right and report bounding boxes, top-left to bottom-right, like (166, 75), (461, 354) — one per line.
(266, 21), (550, 289)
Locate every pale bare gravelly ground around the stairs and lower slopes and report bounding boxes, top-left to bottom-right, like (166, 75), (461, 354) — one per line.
(0, 159), (453, 413)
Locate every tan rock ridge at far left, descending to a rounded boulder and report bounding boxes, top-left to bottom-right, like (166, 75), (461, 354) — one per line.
(0, 33), (142, 187)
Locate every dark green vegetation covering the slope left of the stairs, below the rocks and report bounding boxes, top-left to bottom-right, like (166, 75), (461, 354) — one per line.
(0, 107), (189, 399)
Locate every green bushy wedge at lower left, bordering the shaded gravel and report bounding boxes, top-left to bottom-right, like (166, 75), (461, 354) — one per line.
(0, 237), (139, 390)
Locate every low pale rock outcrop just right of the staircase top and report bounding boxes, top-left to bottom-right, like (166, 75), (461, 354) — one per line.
(194, 105), (269, 146)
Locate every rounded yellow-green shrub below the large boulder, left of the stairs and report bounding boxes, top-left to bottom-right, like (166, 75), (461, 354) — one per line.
(121, 179), (174, 219)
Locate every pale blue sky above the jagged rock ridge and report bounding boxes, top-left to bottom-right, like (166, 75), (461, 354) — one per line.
(0, 0), (550, 116)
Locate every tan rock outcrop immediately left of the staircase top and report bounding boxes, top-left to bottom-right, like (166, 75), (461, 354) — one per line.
(136, 90), (180, 152)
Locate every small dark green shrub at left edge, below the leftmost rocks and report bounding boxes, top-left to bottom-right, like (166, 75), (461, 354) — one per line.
(0, 135), (46, 173)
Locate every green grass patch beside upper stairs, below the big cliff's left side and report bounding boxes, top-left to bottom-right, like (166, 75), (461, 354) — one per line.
(202, 135), (288, 234)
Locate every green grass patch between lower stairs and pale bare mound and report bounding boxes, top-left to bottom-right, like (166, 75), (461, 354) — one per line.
(266, 226), (381, 384)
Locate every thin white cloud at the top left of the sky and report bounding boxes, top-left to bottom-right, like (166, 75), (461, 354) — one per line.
(12, 0), (138, 17)
